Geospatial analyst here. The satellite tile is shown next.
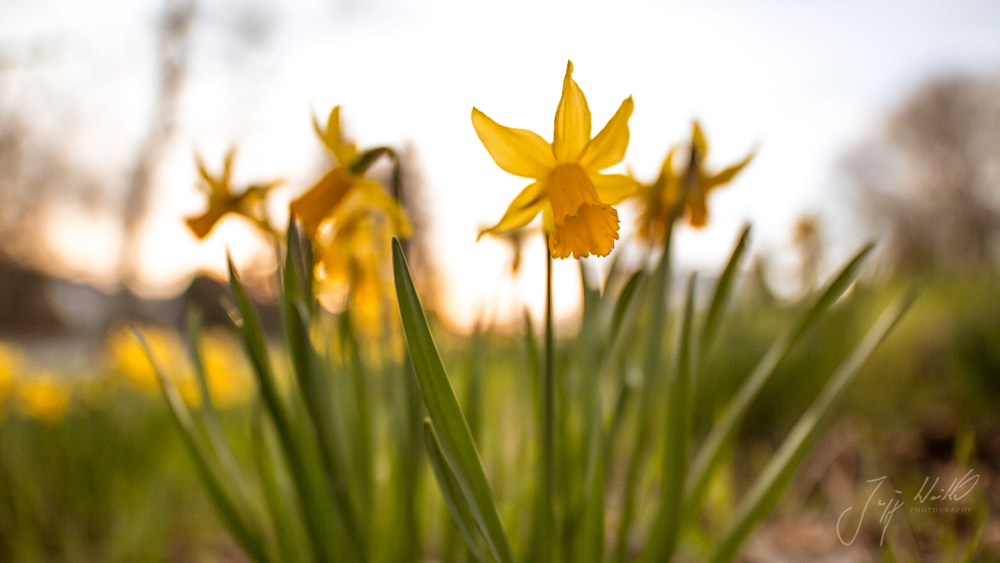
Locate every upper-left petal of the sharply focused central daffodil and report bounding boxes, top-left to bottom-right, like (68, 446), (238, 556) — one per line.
(472, 108), (556, 179)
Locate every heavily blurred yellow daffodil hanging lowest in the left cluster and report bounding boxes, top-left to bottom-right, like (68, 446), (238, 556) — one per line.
(315, 185), (412, 334)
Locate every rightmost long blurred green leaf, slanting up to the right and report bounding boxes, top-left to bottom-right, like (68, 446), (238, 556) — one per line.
(711, 290), (915, 563)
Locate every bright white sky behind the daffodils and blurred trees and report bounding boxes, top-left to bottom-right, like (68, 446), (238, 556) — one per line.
(0, 0), (1000, 325)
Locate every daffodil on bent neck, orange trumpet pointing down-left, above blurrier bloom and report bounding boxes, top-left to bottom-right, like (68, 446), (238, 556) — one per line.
(290, 106), (399, 240)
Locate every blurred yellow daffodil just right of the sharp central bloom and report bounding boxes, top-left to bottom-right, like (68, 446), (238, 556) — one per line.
(638, 121), (755, 242)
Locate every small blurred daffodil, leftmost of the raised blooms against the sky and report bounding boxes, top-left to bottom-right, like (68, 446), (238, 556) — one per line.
(186, 150), (280, 239)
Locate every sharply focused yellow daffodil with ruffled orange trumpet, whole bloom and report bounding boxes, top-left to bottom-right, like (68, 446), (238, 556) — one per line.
(472, 61), (638, 258)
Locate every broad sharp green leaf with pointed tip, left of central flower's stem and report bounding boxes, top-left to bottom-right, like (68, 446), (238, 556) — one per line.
(392, 238), (514, 563)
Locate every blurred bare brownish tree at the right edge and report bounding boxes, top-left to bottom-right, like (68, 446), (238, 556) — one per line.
(844, 78), (1000, 271)
